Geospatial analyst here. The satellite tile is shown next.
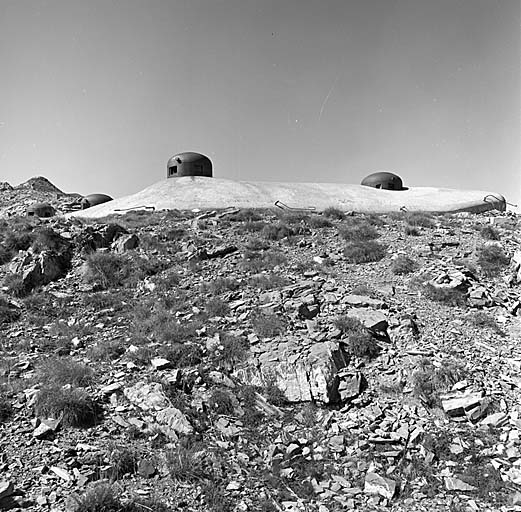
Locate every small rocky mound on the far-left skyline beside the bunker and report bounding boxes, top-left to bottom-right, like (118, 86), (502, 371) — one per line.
(0, 176), (82, 218)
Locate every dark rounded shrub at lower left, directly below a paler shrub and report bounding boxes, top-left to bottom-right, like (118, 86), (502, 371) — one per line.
(34, 386), (100, 427)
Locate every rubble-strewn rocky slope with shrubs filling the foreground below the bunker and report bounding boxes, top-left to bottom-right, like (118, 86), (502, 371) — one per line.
(0, 205), (521, 512)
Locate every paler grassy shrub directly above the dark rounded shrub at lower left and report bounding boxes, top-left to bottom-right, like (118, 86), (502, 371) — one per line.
(37, 357), (94, 387)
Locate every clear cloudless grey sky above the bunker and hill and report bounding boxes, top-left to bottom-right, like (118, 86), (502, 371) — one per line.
(0, 0), (521, 206)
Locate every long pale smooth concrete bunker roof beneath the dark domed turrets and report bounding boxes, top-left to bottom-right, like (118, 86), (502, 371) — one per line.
(69, 176), (506, 218)
